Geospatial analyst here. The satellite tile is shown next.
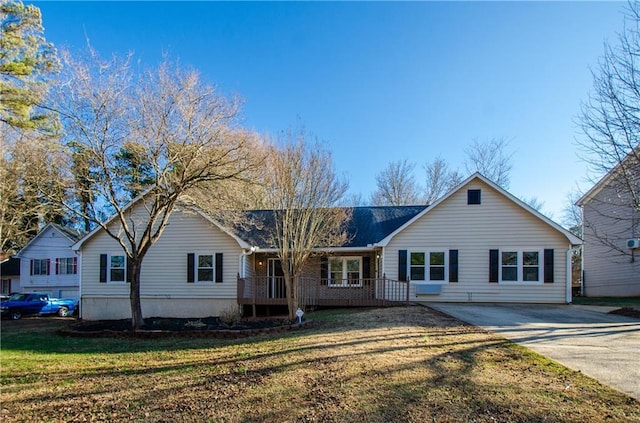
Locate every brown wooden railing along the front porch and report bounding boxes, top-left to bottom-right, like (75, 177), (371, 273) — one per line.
(238, 277), (409, 307)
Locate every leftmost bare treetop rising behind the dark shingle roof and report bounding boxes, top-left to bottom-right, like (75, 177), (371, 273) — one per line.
(371, 160), (420, 206)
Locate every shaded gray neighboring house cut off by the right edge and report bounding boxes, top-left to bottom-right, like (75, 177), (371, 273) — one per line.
(576, 156), (640, 297)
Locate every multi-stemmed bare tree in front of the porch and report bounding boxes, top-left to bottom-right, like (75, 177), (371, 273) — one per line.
(264, 129), (350, 320)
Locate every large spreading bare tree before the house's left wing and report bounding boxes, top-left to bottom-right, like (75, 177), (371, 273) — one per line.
(57, 51), (262, 328)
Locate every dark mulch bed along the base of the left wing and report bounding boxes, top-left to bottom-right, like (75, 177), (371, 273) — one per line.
(60, 317), (312, 338)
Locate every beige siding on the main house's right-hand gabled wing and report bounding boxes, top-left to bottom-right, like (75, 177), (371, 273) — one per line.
(384, 179), (569, 303)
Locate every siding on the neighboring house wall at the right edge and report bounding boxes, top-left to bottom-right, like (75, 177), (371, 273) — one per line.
(583, 187), (640, 297)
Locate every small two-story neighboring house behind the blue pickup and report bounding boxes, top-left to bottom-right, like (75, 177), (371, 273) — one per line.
(16, 223), (82, 300)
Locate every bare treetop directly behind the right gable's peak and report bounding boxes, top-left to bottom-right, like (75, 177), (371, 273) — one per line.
(464, 138), (513, 189)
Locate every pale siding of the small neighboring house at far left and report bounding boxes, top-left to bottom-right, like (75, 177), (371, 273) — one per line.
(20, 226), (80, 300)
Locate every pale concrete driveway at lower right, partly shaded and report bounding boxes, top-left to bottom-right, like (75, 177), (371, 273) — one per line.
(428, 303), (640, 399)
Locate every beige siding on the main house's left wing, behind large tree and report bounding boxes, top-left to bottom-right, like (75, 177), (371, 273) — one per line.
(82, 205), (242, 318)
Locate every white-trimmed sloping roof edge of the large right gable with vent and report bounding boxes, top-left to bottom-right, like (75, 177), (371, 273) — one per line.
(378, 172), (582, 246)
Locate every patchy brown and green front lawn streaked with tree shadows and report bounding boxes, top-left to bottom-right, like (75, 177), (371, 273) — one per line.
(0, 306), (640, 422)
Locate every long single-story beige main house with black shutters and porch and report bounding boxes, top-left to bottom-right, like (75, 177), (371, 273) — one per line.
(73, 174), (581, 320)
